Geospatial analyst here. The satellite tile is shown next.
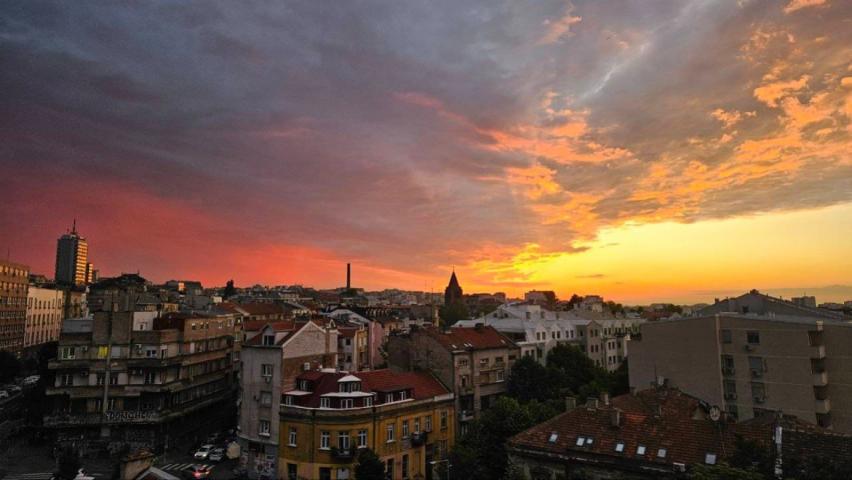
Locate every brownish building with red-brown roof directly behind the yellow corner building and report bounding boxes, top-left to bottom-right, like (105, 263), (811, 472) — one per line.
(387, 325), (521, 434)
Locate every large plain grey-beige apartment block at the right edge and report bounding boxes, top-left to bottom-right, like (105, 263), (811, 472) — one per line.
(630, 313), (852, 432)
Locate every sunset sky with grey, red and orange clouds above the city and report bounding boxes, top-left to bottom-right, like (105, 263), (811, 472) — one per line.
(0, 0), (852, 302)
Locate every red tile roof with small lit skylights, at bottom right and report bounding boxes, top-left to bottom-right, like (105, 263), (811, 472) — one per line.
(509, 388), (772, 466)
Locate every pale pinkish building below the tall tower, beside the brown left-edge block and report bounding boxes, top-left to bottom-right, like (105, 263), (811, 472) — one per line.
(24, 285), (65, 348)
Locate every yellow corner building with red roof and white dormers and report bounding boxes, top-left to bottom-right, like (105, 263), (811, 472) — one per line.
(278, 370), (455, 480)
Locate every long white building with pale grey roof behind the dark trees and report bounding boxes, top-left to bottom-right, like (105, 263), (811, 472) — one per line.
(456, 303), (644, 371)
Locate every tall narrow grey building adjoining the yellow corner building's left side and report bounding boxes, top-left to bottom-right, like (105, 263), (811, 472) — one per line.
(237, 321), (337, 478)
